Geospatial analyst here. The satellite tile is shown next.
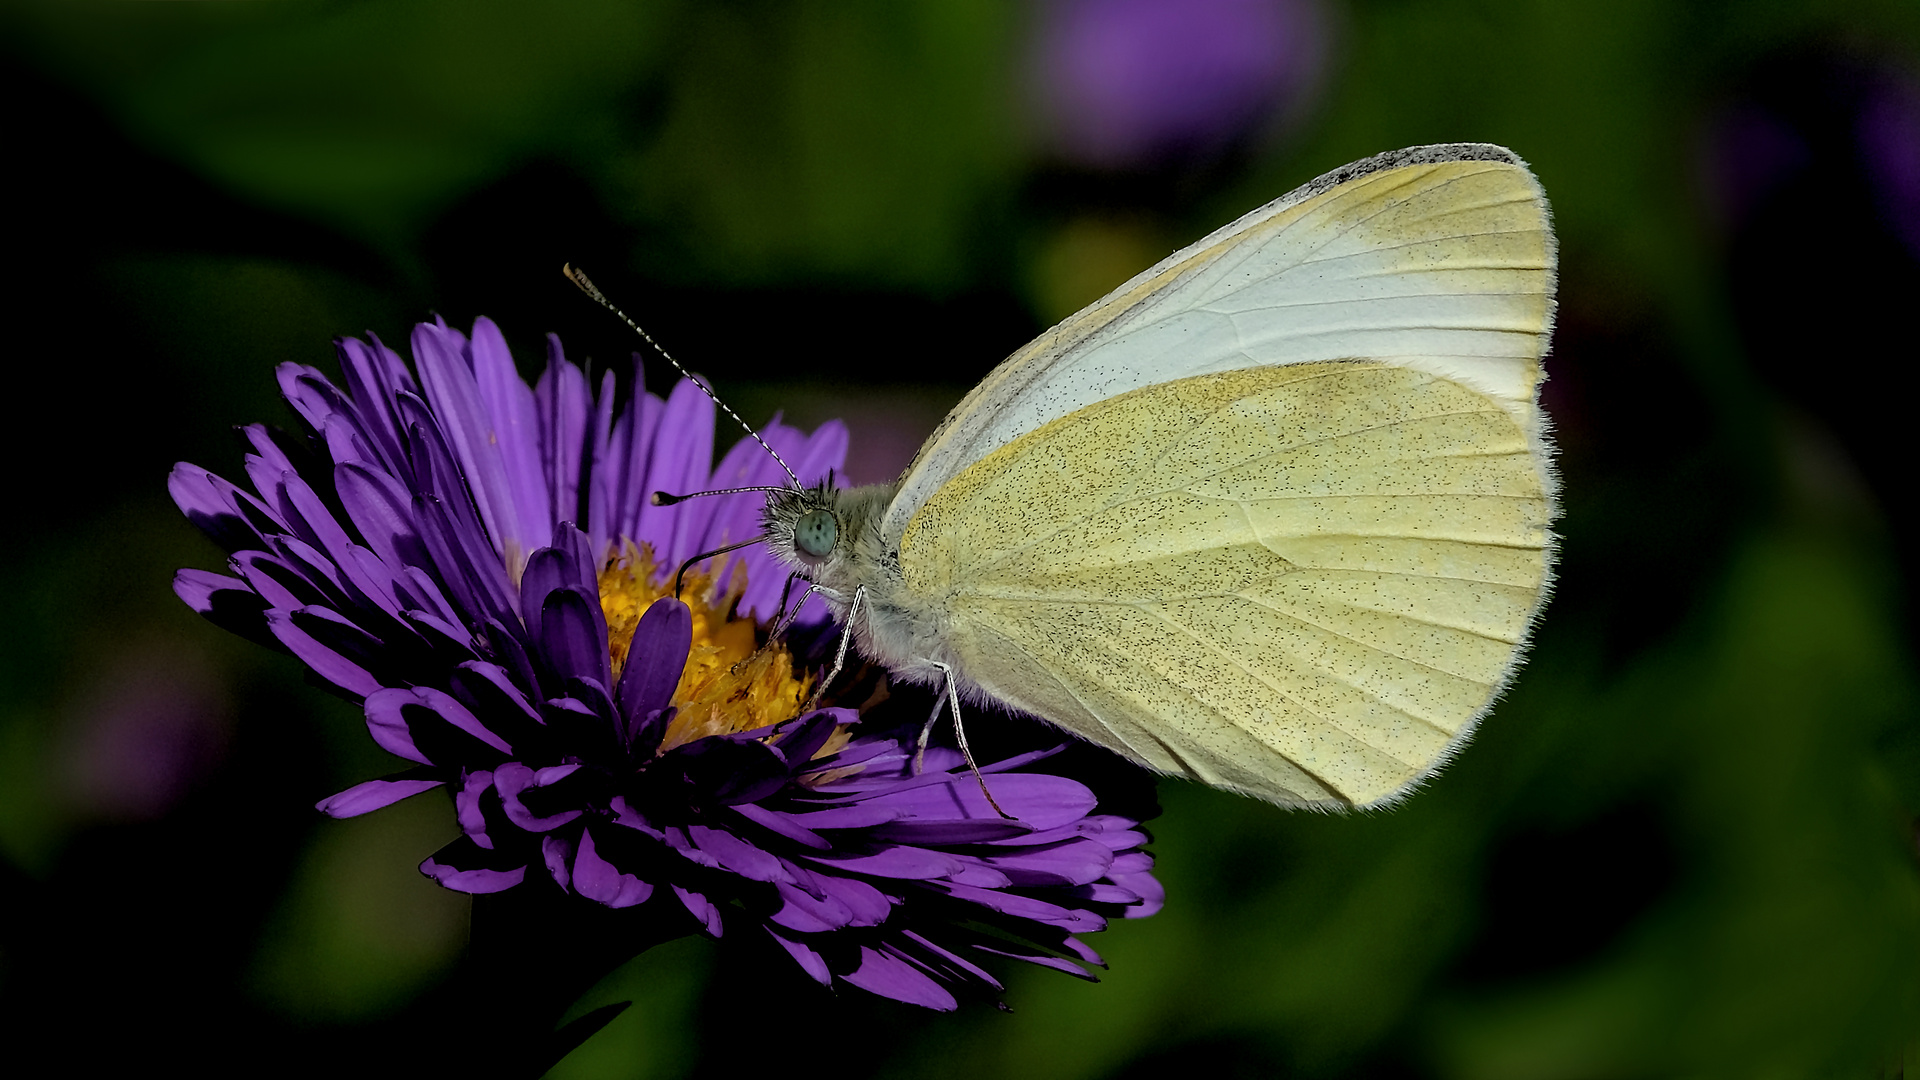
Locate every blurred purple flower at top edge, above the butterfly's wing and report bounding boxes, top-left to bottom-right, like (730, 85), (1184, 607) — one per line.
(1033, 0), (1327, 167)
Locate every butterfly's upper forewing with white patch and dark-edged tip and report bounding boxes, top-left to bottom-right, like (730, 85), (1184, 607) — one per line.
(883, 142), (1555, 538)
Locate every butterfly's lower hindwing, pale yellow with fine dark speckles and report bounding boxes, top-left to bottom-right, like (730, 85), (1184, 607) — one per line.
(900, 361), (1551, 805)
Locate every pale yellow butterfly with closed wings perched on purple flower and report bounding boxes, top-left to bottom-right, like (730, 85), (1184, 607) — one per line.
(664, 144), (1555, 809)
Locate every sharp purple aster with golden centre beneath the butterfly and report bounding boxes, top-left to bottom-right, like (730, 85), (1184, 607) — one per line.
(169, 319), (1162, 1009)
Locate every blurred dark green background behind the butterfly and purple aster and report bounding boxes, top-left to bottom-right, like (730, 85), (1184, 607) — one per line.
(0, 0), (1920, 1080)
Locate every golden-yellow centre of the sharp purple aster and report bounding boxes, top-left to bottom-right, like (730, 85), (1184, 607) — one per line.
(599, 540), (849, 757)
